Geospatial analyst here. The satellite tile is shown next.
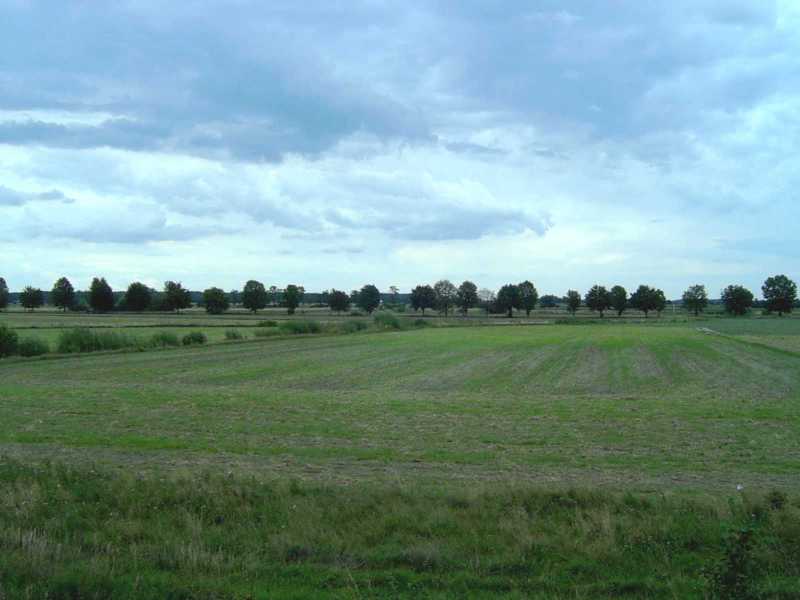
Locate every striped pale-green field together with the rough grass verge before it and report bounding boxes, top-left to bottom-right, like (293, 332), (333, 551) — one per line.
(0, 319), (800, 598)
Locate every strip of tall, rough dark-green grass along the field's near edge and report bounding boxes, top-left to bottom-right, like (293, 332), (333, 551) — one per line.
(0, 458), (800, 599)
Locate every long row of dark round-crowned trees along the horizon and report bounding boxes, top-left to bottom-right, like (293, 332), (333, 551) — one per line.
(0, 275), (797, 318)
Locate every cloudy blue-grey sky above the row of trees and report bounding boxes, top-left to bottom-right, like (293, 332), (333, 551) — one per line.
(0, 0), (800, 298)
